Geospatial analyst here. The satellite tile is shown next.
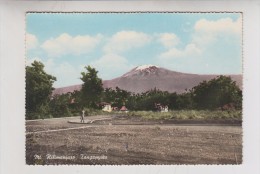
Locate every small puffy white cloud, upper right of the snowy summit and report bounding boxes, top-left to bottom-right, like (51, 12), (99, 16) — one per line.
(158, 33), (180, 48)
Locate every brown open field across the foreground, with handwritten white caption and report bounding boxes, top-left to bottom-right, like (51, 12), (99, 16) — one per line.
(26, 116), (242, 165)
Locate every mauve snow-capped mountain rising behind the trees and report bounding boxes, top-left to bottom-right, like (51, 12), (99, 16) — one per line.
(54, 65), (242, 94)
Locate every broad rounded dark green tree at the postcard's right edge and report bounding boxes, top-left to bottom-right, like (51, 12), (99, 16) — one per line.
(192, 76), (242, 109)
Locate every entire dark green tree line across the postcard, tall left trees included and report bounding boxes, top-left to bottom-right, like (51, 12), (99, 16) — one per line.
(26, 61), (242, 119)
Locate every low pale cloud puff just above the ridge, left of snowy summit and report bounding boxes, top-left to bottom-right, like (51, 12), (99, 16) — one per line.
(90, 53), (133, 79)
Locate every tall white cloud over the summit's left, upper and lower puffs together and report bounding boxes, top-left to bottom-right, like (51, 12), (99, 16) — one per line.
(90, 31), (150, 79)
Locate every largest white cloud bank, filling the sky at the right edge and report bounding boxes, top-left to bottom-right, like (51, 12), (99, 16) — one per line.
(158, 17), (242, 74)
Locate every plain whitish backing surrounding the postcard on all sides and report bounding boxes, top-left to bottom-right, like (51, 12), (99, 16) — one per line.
(0, 0), (260, 174)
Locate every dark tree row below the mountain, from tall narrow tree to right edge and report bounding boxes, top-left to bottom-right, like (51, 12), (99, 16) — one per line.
(100, 76), (242, 110)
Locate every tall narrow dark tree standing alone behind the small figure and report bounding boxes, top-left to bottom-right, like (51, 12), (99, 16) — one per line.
(80, 66), (103, 108)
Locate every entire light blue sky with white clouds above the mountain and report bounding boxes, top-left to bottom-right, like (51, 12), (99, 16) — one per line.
(26, 13), (242, 87)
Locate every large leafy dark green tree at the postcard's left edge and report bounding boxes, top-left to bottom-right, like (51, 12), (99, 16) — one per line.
(26, 61), (56, 119)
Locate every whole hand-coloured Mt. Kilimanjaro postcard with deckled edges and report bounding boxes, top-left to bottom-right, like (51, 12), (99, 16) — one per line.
(25, 12), (243, 165)
